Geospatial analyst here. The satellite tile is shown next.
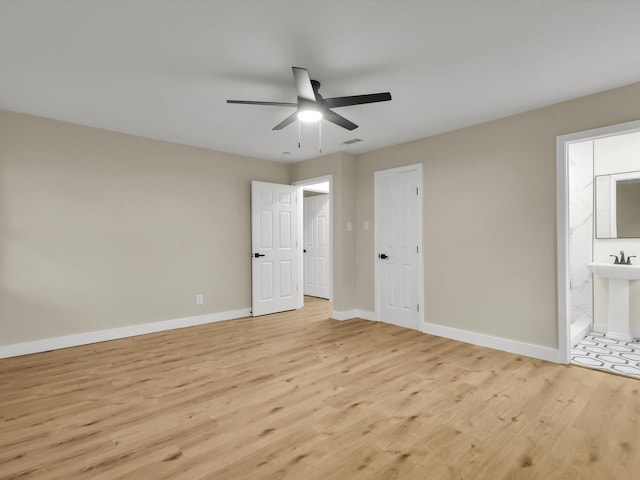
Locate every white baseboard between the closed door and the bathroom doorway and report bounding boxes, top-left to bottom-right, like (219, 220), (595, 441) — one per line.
(422, 323), (562, 363)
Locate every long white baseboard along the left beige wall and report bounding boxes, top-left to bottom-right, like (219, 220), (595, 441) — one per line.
(0, 308), (251, 358)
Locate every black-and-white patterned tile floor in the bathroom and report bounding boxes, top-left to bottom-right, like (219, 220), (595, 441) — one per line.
(571, 332), (640, 378)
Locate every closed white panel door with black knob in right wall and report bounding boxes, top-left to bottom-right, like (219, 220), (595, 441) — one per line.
(375, 165), (422, 330)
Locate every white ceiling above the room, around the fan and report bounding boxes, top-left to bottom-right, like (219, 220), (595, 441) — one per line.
(0, 0), (640, 162)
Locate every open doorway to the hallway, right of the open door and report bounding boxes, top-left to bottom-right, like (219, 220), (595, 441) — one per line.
(294, 175), (333, 303)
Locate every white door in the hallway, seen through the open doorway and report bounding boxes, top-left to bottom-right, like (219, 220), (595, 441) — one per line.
(303, 193), (331, 299)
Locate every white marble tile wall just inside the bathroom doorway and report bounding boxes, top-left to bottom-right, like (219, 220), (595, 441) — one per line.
(569, 140), (593, 324)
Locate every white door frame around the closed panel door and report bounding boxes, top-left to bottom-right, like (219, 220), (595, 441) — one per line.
(373, 163), (425, 332)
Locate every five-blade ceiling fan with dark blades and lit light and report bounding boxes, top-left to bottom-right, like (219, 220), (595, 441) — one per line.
(227, 67), (391, 130)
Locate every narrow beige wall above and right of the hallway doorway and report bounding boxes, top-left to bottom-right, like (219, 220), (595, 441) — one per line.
(291, 153), (356, 312)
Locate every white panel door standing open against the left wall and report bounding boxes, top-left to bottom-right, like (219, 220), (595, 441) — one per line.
(251, 182), (302, 316)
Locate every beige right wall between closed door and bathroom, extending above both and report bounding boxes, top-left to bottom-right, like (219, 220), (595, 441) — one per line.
(356, 79), (640, 348)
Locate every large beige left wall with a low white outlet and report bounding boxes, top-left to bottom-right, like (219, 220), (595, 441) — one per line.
(0, 111), (289, 345)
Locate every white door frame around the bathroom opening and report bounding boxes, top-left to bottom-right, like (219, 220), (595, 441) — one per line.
(556, 120), (640, 363)
